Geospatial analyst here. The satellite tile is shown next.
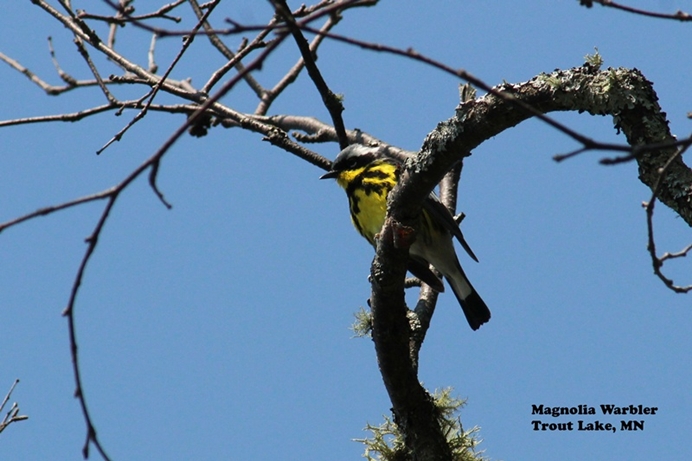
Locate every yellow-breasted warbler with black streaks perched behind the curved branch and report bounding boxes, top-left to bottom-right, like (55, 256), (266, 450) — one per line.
(320, 144), (490, 331)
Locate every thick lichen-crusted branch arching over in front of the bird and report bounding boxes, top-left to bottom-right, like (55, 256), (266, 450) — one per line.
(371, 64), (692, 459)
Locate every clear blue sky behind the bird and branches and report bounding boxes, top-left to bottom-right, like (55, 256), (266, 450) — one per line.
(0, 0), (692, 461)
